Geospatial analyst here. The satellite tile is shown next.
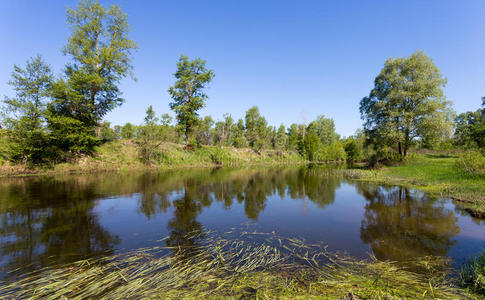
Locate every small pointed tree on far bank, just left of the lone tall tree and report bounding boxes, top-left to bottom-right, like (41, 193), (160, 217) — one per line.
(136, 105), (163, 165)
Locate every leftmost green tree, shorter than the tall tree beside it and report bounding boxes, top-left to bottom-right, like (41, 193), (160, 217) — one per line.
(3, 55), (53, 163)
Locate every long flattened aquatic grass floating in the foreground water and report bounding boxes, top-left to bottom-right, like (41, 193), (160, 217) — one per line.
(0, 230), (470, 299)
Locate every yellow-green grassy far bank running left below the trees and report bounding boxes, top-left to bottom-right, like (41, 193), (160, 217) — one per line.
(0, 140), (305, 177)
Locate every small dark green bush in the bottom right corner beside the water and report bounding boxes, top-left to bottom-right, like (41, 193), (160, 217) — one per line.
(460, 251), (485, 295)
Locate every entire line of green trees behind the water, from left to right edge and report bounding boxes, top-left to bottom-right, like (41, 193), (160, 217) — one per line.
(0, 0), (485, 169)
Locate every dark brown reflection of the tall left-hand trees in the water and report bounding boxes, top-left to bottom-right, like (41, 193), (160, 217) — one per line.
(0, 178), (119, 276)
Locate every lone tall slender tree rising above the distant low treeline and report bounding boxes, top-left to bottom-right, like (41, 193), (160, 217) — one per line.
(168, 55), (214, 146)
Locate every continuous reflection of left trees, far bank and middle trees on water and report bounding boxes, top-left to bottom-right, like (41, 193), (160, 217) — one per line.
(0, 167), (346, 278)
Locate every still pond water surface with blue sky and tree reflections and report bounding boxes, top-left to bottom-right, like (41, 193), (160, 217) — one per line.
(0, 167), (485, 279)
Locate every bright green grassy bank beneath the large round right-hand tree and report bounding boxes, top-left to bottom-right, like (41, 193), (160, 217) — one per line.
(339, 154), (485, 218)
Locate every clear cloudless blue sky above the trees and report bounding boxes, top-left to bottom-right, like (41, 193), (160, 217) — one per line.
(0, 0), (485, 136)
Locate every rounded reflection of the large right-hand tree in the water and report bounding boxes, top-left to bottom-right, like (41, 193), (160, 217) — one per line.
(357, 183), (460, 261)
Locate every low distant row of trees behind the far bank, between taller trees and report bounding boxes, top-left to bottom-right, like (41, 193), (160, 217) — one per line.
(98, 106), (346, 162)
